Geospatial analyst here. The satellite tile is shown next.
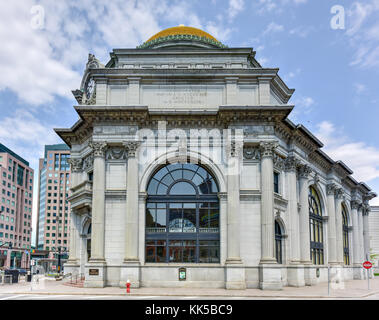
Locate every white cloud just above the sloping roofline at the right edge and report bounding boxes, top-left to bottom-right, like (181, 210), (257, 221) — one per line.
(315, 121), (379, 182)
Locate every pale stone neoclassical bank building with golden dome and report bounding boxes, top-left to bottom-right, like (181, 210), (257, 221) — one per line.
(55, 25), (376, 289)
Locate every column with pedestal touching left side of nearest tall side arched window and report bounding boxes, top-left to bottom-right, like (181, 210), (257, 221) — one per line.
(298, 164), (316, 286)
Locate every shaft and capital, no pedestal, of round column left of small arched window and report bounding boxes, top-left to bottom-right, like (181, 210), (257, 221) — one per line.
(260, 142), (277, 264)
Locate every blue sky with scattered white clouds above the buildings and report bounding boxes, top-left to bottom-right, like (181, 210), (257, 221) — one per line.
(0, 0), (379, 244)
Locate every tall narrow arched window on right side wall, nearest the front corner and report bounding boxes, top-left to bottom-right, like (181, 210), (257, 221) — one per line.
(308, 187), (324, 264)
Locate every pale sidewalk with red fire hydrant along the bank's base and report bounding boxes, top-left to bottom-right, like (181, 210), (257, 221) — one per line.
(0, 277), (379, 299)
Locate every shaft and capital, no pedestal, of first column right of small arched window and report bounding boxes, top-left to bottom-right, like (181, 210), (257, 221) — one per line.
(285, 156), (300, 263)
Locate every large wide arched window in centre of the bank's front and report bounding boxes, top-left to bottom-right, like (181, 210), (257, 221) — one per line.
(145, 163), (220, 263)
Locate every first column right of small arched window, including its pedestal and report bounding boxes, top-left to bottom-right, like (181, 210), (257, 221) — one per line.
(285, 156), (305, 287)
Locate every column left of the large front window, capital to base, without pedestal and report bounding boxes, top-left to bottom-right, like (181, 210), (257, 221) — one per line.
(124, 141), (140, 263)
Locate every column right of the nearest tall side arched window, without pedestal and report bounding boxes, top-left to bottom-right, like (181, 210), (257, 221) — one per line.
(326, 183), (337, 264)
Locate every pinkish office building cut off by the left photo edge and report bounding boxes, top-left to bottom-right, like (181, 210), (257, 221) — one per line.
(0, 143), (34, 268)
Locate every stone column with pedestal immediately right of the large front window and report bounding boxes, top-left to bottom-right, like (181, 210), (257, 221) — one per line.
(225, 136), (246, 289)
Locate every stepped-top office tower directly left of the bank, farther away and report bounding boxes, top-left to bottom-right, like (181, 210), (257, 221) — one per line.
(36, 144), (71, 265)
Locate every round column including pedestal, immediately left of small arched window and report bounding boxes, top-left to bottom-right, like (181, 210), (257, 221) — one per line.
(259, 141), (282, 290)
